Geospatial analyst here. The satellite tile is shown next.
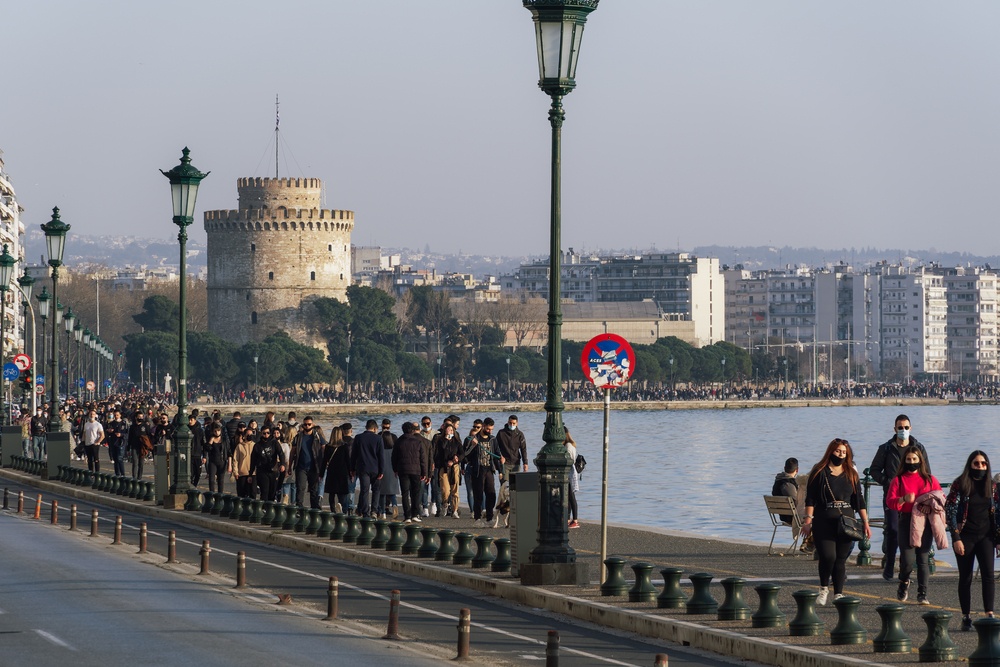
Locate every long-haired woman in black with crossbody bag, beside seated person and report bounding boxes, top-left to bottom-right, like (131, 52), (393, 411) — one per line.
(802, 438), (872, 605)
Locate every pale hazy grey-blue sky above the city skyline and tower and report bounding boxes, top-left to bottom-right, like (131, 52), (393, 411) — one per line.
(0, 0), (1000, 255)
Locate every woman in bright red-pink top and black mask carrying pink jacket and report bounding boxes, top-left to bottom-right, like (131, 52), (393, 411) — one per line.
(885, 445), (947, 604)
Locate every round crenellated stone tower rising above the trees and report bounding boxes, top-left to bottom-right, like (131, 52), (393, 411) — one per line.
(205, 178), (354, 347)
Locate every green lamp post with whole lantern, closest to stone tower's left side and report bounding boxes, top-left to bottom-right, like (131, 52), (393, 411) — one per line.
(160, 147), (209, 504)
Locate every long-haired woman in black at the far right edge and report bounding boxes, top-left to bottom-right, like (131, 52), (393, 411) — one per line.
(944, 449), (1000, 632)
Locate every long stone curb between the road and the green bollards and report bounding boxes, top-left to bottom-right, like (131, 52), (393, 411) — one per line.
(0, 469), (884, 667)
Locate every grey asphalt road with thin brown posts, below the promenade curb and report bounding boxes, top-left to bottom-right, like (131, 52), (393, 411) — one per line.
(0, 484), (747, 667)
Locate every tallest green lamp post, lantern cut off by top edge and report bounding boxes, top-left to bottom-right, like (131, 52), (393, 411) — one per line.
(521, 0), (599, 585)
